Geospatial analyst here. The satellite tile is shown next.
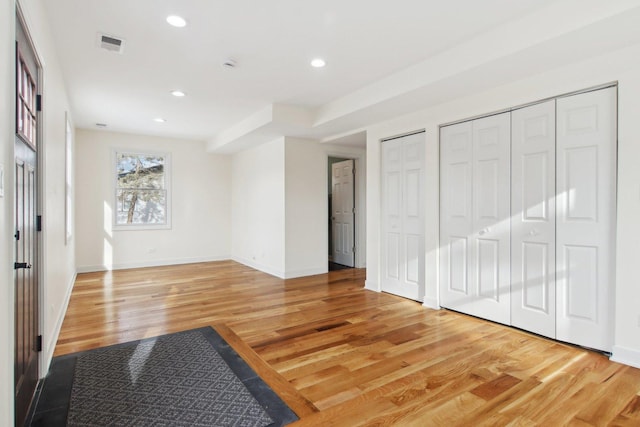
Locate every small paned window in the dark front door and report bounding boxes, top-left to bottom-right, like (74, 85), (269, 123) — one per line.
(16, 50), (37, 147)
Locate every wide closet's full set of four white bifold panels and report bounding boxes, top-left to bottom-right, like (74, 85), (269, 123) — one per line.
(440, 87), (617, 351)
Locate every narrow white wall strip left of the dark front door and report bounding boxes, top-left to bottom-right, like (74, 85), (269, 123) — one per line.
(0, 0), (15, 426)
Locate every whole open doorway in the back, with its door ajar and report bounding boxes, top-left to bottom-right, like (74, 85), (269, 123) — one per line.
(327, 157), (356, 271)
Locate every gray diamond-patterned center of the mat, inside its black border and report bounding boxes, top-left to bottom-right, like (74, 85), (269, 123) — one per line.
(68, 331), (273, 427)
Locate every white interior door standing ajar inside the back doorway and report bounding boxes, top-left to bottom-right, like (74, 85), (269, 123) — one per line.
(331, 160), (355, 267)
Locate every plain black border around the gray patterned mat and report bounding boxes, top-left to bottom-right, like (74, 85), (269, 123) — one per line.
(28, 326), (298, 427)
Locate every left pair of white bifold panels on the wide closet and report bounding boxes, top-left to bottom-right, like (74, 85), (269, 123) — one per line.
(440, 113), (511, 324)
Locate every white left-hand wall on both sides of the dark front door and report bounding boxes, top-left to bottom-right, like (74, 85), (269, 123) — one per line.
(0, 0), (75, 425)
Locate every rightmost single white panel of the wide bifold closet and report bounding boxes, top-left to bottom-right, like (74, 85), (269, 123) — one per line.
(556, 88), (617, 351)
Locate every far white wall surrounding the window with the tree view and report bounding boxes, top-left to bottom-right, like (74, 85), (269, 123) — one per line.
(75, 129), (231, 271)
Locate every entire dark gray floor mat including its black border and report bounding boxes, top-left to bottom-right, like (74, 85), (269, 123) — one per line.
(31, 328), (297, 427)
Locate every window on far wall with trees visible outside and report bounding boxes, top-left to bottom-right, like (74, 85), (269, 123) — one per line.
(115, 151), (170, 230)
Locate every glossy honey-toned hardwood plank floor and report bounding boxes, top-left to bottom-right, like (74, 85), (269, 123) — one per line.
(55, 261), (640, 426)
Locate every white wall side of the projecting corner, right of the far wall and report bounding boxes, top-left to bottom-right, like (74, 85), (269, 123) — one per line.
(231, 138), (285, 277)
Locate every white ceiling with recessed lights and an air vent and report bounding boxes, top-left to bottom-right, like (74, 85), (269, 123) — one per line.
(43, 0), (639, 151)
